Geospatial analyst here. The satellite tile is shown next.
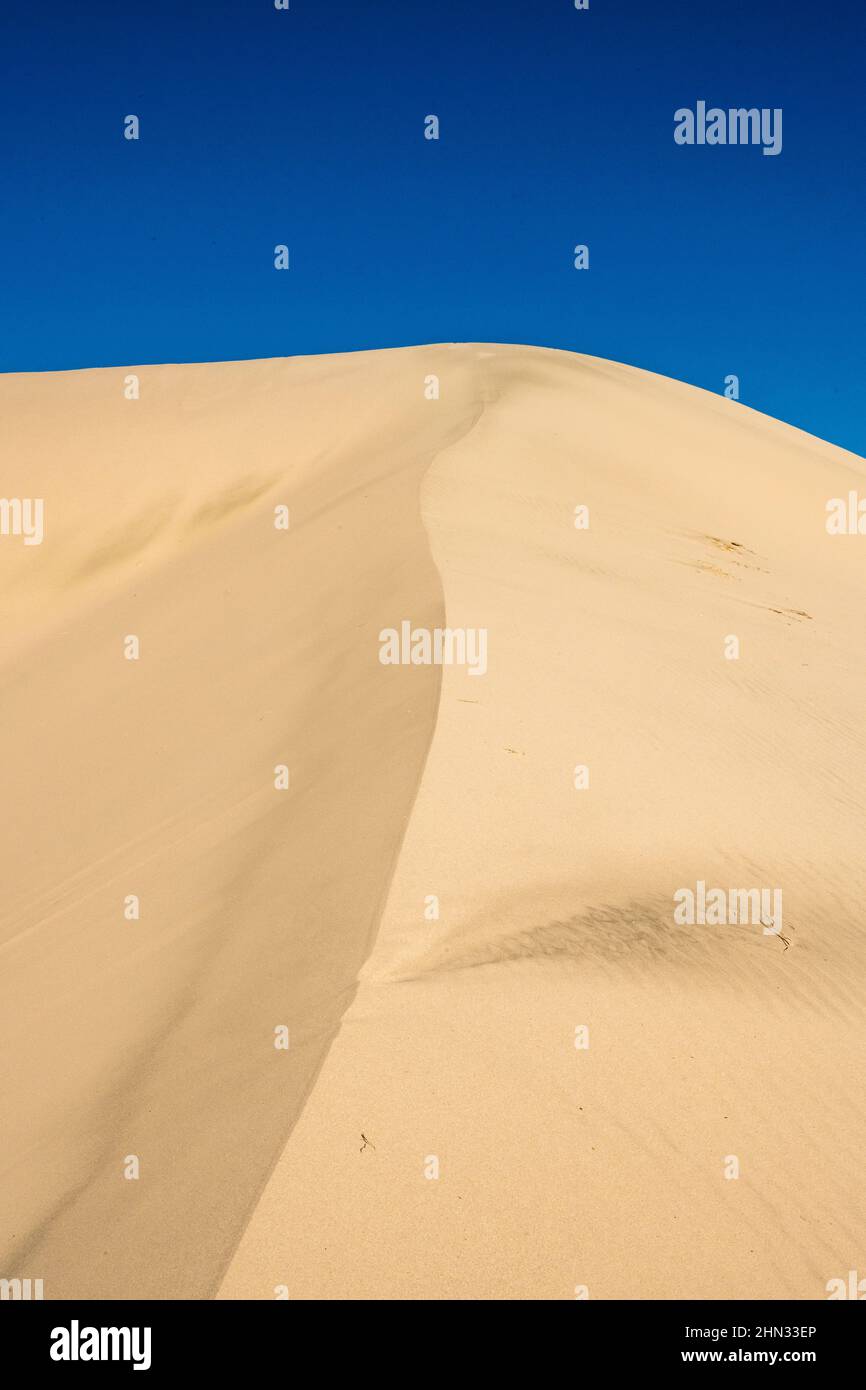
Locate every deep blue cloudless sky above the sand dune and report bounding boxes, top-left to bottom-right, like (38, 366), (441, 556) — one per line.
(0, 0), (866, 455)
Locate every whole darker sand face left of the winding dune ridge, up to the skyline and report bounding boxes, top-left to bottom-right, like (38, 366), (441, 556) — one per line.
(0, 344), (478, 1298)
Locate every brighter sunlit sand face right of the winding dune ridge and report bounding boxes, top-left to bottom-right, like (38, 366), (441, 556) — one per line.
(220, 346), (866, 1298)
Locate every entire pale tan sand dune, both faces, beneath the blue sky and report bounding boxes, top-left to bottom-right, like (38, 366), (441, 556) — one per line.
(0, 345), (866, 1300)
